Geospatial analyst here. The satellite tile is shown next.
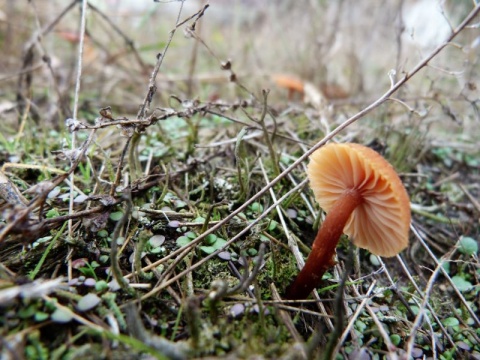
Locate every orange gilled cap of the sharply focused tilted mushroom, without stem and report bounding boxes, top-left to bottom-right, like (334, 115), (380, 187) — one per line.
(308, 143), (410, 257)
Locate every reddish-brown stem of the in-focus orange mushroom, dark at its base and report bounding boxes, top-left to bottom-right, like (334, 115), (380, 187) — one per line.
(286, 189), (362, 300)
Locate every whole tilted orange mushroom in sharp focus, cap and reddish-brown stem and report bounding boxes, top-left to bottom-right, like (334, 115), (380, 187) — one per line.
(286, 143), (410, 299)
